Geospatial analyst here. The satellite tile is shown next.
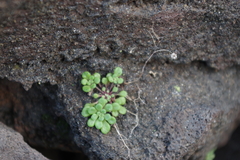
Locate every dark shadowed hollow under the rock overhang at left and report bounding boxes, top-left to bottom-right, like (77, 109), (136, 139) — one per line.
(0, 79), (80, 152)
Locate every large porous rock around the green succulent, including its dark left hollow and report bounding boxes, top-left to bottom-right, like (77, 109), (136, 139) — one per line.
(0, 0), (240, 160)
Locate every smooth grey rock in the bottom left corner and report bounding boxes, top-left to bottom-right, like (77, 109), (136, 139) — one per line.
(0, 122), (47, 160)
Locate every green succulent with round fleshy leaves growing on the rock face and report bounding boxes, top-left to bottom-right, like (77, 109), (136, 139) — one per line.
(81, 67), (127, 134)
